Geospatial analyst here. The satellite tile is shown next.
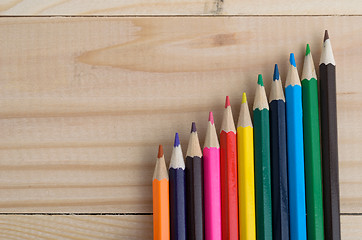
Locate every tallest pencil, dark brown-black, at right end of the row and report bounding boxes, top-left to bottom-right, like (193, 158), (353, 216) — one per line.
(319, 30), (341, 240)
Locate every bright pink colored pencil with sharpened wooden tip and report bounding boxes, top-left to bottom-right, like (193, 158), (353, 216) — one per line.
(203, 112), (221, 240)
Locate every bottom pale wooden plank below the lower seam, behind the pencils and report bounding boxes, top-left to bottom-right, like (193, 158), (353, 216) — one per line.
(0, 215), (362, 240)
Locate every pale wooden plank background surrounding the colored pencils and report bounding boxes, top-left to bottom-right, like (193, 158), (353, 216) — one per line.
(0, 0), (362, 239)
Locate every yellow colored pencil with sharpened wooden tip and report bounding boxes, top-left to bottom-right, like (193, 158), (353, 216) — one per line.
(236, 93), (256, 240)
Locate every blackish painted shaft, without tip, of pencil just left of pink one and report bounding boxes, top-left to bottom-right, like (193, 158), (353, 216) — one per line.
(186, 156), (204, 240)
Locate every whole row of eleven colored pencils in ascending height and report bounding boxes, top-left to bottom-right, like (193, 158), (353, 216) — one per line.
(153, 31), (340, 240)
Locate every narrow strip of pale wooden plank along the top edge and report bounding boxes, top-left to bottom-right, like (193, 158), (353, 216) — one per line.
(0, 0), (362, 16)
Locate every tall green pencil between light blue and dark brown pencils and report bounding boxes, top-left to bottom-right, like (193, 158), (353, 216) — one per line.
(302, 44), (324, 240)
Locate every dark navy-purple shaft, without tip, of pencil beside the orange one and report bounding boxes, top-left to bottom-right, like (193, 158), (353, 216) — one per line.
(169, 168), (186, 240)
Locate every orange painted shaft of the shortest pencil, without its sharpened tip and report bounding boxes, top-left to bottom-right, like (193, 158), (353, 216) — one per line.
(152, 179), (170, 240)
